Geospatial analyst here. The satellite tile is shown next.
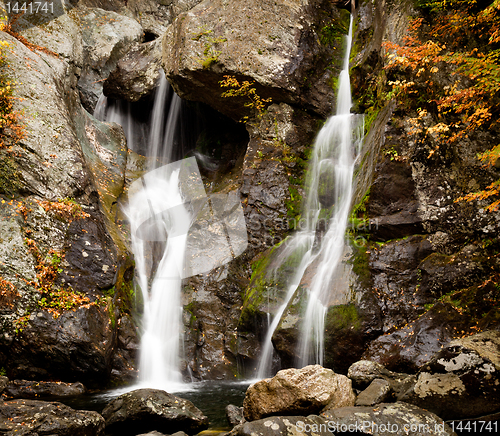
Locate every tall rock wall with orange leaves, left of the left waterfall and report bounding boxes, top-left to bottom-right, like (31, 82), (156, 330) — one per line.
(0, 5), (135, 386)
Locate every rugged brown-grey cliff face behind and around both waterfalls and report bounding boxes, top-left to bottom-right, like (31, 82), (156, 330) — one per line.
(0, 0), (500, 383)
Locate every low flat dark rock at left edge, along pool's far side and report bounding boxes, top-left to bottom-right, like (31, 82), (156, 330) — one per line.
(3, 380), (86, 398)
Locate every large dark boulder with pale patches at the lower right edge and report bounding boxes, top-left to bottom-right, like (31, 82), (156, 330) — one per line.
(400, 331), (500, 419)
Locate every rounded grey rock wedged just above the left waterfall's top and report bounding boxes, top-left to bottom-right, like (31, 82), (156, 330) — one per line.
(103, 40), (161, 102)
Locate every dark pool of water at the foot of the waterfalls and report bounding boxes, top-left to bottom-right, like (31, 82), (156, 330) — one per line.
(53, 381), (250, 430)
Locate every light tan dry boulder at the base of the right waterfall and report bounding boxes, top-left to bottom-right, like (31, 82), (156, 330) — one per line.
(243, 365), (356, 421)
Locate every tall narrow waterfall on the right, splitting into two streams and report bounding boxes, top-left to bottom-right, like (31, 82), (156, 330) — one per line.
(257, 15), (364, 378)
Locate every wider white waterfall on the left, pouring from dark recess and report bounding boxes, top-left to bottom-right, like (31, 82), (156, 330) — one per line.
(94, 71), (190, 391)
